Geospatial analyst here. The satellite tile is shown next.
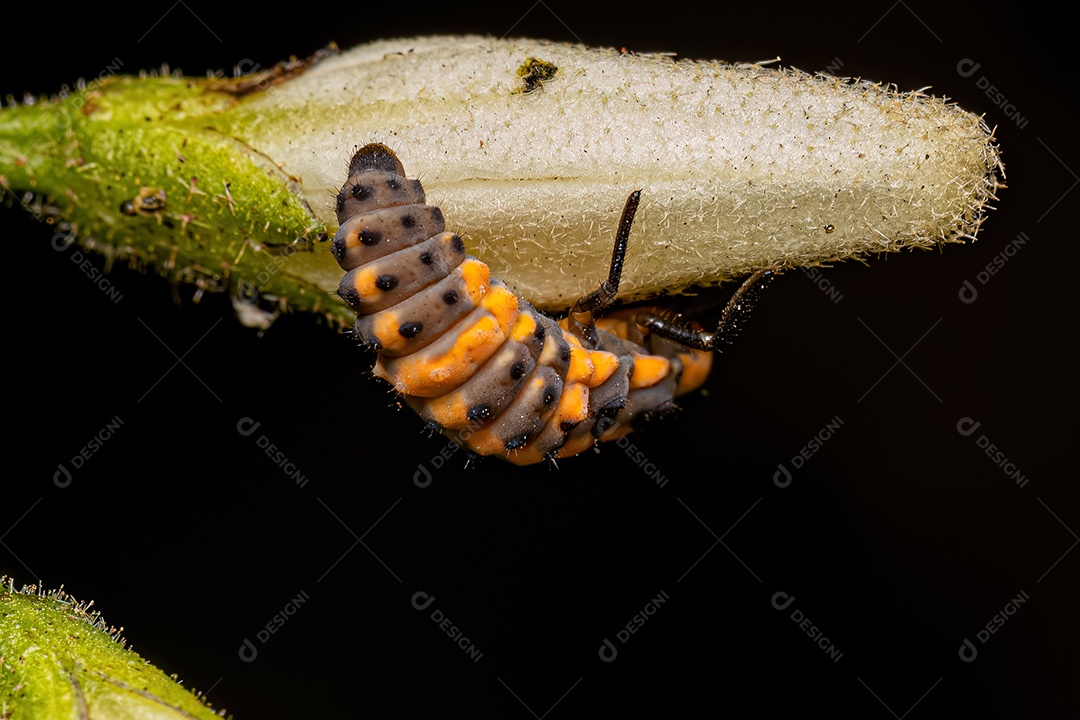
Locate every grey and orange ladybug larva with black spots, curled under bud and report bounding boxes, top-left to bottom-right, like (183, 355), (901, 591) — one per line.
(332, 144), (774, 465)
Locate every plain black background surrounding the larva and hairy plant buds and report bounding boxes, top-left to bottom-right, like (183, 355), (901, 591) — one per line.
(0, 0), (1080, 719)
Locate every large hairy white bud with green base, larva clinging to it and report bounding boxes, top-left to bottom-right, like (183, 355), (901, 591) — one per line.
(0, 37), (1003, 323)
